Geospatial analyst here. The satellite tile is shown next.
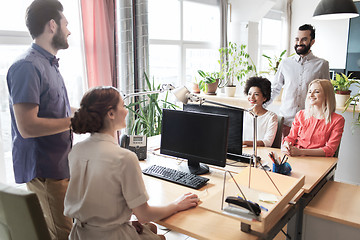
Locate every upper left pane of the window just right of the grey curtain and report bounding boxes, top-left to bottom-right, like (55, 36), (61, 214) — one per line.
(148, 0), (180, 40)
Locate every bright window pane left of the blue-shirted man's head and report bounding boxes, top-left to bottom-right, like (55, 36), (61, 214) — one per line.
(0, 0), (32, 31)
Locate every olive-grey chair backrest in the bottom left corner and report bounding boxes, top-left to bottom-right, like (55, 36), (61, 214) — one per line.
(0, 183), (51, 240)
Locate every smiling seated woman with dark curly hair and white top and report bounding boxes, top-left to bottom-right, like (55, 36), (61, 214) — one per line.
(243, 77), (278, 147)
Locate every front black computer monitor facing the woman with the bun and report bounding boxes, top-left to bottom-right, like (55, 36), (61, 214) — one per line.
(160, 109), (229, 175)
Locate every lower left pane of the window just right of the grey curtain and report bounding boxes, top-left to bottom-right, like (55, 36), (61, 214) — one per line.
(149, 45), (180, 86)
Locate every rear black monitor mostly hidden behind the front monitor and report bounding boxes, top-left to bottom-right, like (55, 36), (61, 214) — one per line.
(183, 104), (244, 161)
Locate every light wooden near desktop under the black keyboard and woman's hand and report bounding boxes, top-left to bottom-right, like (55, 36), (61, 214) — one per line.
(140, 154), (259, 240)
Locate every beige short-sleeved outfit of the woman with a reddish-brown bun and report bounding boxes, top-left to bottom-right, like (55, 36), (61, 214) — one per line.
(64, 133), (148, 240)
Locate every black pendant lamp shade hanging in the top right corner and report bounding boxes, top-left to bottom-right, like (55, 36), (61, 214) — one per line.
(313, 0), (359, 20)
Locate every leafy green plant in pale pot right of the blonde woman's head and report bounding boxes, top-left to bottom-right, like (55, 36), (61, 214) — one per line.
(331, 73), (357, 107)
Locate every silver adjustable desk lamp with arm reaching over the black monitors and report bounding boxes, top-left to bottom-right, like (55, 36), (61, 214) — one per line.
(171, 86), (258, 187)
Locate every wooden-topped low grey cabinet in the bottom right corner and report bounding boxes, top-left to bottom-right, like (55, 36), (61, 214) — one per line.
(302, 181), (360, 240)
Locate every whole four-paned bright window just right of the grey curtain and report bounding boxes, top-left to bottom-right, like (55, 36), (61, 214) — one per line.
(148, 0), (220, 86)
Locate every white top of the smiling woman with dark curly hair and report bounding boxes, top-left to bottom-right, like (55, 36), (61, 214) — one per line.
(243, 111), (278, 147)
